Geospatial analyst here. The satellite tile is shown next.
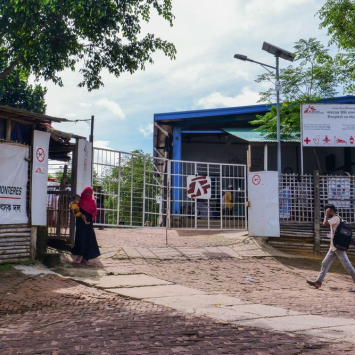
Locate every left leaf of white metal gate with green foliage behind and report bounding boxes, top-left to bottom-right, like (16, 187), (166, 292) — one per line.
(93, 148), (168, 227)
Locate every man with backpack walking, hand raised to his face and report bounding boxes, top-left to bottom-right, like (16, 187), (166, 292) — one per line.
(307, 205), (355, 292)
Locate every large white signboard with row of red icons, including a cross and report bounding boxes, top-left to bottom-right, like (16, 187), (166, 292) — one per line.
(301, 104), (355, 148)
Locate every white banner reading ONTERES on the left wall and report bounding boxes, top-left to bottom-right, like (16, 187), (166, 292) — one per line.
(0, 143), (29, 224)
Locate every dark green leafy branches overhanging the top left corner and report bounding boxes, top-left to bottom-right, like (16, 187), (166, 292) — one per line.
(0, 0), (176, 90)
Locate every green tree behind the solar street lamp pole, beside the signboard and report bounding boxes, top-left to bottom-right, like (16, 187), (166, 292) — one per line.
(250, 38), (339, 139)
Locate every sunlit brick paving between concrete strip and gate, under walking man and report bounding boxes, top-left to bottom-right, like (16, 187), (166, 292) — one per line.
(104, 258), (355, 319)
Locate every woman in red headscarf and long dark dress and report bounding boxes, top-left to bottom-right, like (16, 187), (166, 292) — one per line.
(72, 186), (100, 265)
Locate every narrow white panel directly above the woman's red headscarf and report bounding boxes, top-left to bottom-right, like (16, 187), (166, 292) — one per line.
(76, 139), (92, 195)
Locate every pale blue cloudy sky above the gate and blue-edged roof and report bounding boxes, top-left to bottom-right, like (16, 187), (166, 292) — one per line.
(43, 0), (329, 153)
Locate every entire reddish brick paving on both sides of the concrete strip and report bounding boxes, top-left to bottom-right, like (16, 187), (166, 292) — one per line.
(0, 231), (355, 355)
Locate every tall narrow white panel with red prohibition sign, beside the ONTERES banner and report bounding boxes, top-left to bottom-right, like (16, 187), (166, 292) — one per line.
(31, 130), (51, 226)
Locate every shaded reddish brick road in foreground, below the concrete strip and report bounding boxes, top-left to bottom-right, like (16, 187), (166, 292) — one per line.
(0, 270), (353, 355)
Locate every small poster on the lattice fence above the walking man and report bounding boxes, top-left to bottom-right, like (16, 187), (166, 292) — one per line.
(328, 177), (351, 208)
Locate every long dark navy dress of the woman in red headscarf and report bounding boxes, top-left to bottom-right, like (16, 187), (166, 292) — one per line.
(71, 209), (100, 260)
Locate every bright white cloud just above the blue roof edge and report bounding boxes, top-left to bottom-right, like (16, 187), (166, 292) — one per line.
(194, 87), (259, 109)
